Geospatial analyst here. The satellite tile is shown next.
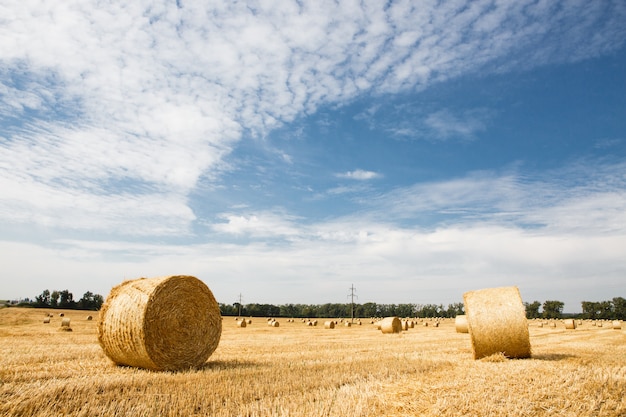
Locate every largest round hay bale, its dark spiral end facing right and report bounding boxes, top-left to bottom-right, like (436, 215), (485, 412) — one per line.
(98, 275), (222, 371)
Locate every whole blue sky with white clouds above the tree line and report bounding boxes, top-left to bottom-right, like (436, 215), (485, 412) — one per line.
(0, 0), (626, 312)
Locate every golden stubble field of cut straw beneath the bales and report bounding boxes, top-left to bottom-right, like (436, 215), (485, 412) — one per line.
(0, 308), (626, 417)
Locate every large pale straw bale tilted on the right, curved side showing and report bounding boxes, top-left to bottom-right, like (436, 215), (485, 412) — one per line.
(463, 287), (530, 359)
